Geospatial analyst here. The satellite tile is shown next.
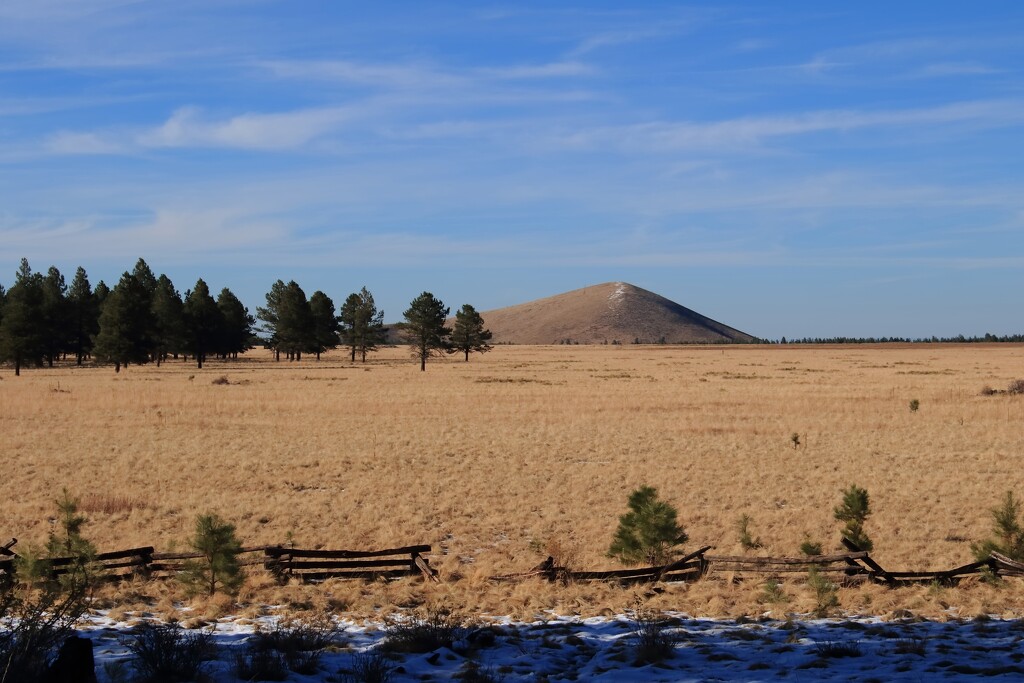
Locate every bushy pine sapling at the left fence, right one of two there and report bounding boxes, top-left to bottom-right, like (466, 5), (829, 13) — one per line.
(180, 514), (245, 595)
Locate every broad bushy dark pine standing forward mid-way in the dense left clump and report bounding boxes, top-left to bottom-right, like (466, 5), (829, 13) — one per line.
(92, 272), (154, 373)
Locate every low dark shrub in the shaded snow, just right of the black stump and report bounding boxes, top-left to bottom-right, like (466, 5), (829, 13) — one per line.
(125, 624), (216, 683)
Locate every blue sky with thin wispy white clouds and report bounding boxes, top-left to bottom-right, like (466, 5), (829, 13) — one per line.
(0, 0), (1024, 338)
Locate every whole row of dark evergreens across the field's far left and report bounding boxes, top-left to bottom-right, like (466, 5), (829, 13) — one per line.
(0, 259), (490, 375)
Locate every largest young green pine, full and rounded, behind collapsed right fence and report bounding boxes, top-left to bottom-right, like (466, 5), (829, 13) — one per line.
(608, 486), (689, 565)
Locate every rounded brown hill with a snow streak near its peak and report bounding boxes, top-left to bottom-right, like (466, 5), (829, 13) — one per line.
(481, 283), (754, 344)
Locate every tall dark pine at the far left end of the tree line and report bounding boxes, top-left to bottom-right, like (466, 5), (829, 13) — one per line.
(0, 258), (43, 376)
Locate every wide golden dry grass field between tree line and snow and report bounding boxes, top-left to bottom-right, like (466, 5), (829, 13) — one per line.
(0, 345), (1024, 615)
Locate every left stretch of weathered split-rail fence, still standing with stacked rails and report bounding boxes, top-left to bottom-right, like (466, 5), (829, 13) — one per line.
(0, 539), (438, 582)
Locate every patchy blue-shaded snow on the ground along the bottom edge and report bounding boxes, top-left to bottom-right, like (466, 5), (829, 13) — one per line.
(75, 613), (1024, 683)
